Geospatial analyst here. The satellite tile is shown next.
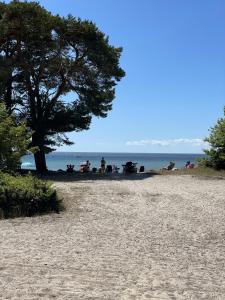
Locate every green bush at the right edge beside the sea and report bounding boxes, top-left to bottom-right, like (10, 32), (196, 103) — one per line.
(199, 109), (225, 170)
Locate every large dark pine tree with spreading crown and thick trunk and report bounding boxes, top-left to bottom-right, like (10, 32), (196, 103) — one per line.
(0, 1), (125, 171)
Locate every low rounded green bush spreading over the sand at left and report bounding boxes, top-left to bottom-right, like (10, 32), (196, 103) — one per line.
(0, 172), (61, 218)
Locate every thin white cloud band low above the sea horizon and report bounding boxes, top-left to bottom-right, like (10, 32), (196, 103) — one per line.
(126, 138), (208, 147)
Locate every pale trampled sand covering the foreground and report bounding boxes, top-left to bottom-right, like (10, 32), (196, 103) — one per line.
(0, 176), (225, 300)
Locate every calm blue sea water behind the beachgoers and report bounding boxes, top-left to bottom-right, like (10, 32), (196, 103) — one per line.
(22, 152), (205, 171)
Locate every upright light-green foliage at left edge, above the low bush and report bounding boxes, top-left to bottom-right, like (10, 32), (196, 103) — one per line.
(0, 103), (31, 170)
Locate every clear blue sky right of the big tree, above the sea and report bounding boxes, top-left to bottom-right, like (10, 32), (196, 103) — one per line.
(5, 0), (225, 153)
